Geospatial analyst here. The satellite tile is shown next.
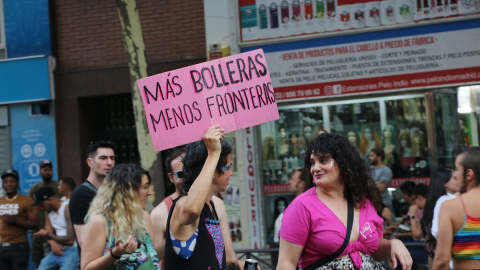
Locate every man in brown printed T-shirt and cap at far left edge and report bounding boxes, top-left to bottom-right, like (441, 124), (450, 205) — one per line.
(0, 169), (38, 270)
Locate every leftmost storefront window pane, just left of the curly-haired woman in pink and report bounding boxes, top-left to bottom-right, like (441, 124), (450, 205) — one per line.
(260, 107), (326, 246)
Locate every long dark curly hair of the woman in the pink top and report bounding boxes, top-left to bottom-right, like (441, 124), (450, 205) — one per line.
(304, 133), (381, 209)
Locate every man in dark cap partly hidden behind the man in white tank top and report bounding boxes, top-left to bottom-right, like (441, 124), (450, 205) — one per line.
(28, 159), (59, 268)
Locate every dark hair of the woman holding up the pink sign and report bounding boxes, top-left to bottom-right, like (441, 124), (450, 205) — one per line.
(182, 140), (233, 192)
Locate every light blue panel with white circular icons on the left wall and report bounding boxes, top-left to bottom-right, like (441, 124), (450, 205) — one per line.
(10, 103), (58, 194)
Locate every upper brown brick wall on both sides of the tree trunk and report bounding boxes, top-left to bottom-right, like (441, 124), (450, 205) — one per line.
(52, 0), (206, 71)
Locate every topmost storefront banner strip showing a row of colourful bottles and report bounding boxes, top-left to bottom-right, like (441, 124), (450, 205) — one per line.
(238, 0), (480, 42)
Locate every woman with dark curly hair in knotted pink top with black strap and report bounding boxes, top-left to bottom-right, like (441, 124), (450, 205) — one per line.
(277, 133), (412, 270)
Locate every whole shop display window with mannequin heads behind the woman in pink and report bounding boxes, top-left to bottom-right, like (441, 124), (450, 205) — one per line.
(260, 89), (468, 246)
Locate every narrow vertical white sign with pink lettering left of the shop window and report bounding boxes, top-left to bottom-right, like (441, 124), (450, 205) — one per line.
(245, 128), (263, 249)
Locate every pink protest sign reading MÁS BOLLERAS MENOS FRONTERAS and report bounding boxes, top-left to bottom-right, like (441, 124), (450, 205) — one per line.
(137, 49), (278, 151)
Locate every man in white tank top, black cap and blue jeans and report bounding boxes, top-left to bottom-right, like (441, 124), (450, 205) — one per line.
(33, 186), (80, 270)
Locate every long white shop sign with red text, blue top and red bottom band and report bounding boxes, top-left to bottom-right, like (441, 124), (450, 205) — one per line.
(256, 19), (480, 100)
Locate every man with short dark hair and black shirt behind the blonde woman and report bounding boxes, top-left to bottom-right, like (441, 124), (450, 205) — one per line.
(70, 141), (115, 254)
